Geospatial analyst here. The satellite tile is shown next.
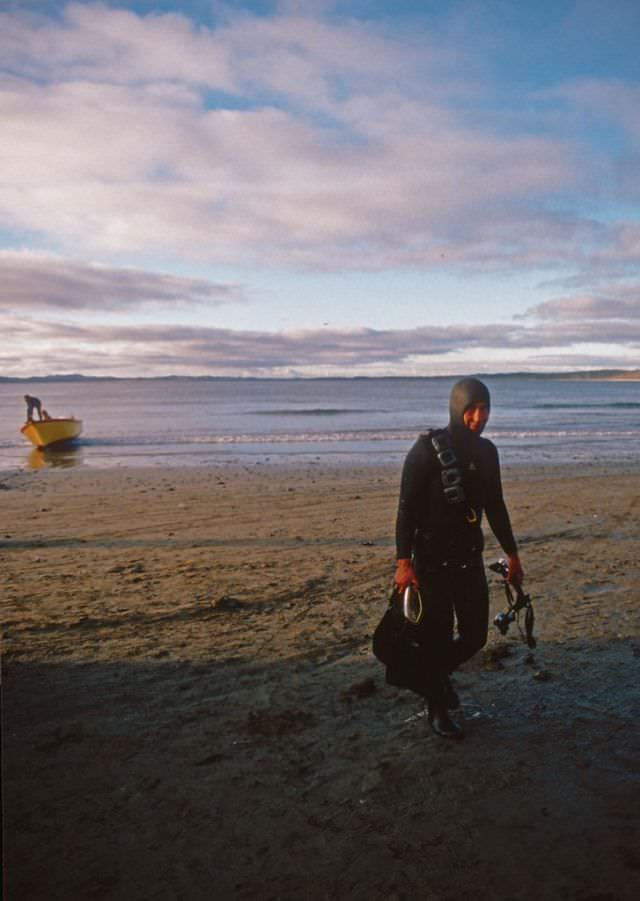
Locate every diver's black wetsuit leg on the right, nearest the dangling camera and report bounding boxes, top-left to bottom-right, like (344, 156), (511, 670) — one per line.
(449, 564), (489, 671)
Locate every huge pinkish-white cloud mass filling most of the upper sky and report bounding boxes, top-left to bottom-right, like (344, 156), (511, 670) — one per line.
(0, 4), (589, 269)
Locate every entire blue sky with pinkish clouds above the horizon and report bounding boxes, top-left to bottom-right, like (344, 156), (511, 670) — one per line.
(0, 0), (640, 377)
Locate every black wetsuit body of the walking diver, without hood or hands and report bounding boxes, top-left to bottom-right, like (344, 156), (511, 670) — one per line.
(387, 414), (517, 703)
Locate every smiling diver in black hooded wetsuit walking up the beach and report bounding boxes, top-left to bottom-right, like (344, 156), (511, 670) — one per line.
(387, 378), (523, 738)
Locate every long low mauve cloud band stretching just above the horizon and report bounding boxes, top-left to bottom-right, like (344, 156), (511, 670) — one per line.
(6, 298), (640, 376)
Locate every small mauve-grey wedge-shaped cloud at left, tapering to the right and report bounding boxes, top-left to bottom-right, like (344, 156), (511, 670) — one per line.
(0, 251), (245, 313)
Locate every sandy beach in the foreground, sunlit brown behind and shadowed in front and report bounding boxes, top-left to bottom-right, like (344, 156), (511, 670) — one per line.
(0, 464), (640, 901)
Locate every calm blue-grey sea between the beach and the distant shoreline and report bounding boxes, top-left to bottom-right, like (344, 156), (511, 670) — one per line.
(0, 376), (640, 470)
